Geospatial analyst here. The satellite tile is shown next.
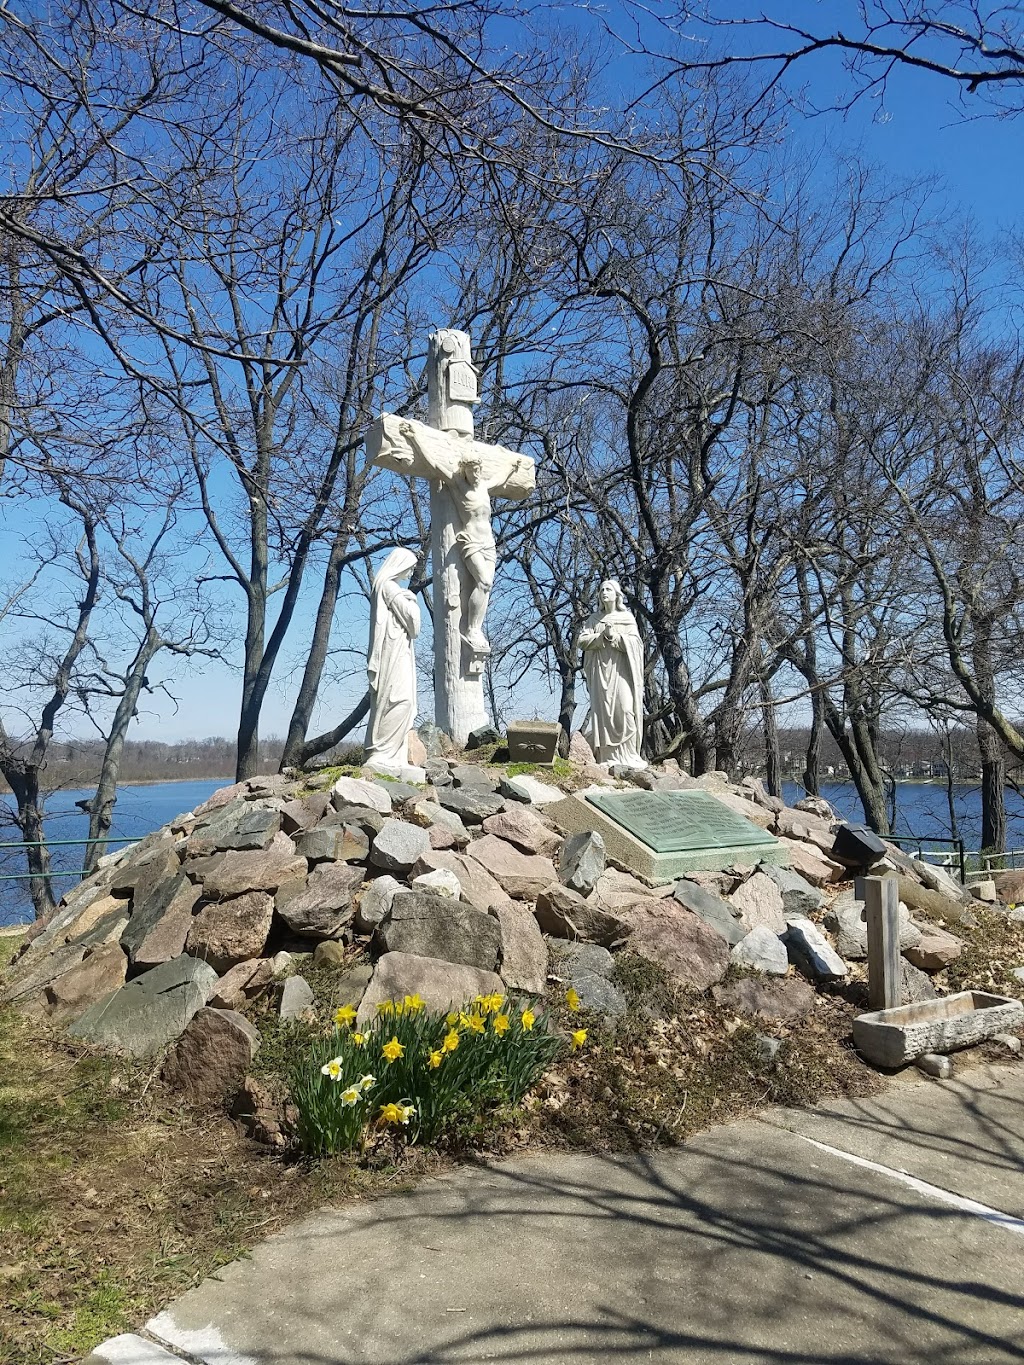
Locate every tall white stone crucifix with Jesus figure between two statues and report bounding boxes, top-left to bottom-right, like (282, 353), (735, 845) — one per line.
(366, 328), (535, 744)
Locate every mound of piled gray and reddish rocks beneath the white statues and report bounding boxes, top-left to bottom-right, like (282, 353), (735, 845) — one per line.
(0, 737), (999, 1093)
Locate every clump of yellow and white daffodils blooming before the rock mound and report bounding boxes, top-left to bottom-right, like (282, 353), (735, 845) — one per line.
(291, 994), (565, 1155)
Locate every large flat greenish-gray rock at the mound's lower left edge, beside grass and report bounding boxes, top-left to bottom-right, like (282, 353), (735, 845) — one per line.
(68, 954), (217, 1057)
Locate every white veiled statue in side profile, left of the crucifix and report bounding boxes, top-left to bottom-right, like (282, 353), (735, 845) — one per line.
(366, 547), (419, 775)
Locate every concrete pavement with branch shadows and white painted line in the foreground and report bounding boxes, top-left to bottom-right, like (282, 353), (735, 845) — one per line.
(90, 1063), (1024, 1365)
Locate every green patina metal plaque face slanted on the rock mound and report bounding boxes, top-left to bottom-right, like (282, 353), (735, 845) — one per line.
(586, 792), (774, 853)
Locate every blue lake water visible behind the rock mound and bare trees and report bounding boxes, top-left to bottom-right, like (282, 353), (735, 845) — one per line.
(0, 778), (1024, 924)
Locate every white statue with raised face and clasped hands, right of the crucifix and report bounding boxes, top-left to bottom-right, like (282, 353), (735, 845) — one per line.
(579, 579), (647, 768)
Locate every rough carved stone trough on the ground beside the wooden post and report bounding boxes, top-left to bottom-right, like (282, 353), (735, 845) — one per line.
(853, 991), (1024, 1066)
